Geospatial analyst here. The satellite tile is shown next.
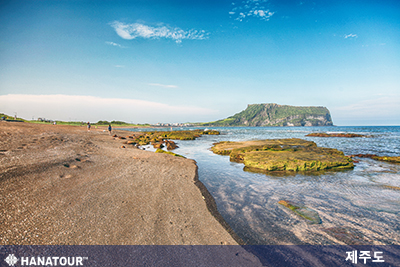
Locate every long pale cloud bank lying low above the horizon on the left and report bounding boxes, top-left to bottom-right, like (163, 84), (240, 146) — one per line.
(0, 94), (217, 123)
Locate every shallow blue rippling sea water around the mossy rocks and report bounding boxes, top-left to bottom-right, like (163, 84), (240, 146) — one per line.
(126, 126), (400, 245)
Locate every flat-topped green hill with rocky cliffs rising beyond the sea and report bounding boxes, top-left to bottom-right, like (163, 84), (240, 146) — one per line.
(201, 104), (333, 126)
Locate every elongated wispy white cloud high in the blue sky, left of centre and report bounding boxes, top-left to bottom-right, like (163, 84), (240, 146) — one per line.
(110, 21), (208, 43)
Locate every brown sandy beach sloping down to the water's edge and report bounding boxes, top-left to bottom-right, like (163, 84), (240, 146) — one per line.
(0, 122), (244, 245)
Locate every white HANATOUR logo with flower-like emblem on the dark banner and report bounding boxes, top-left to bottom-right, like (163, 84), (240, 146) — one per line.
(4, 254), (88, 266)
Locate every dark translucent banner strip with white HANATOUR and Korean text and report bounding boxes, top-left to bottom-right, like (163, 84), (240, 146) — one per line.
(0, 245), (400, 267)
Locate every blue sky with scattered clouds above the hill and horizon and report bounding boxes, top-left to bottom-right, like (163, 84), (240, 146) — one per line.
(0, 0), (400, 126)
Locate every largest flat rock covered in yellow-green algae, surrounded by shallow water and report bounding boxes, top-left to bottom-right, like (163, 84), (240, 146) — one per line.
(211, 138), (354, 172)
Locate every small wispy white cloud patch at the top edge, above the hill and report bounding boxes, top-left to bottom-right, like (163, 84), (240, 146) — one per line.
(229, 0), (275, 21)
